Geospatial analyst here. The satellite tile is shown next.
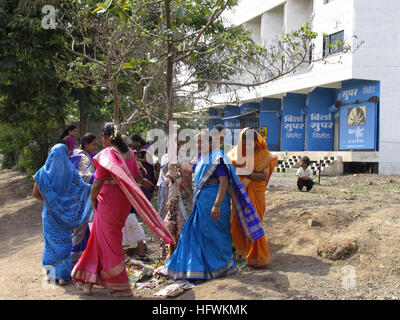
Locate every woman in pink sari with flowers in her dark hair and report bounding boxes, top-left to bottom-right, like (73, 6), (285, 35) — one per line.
(72, 123), (174, 297)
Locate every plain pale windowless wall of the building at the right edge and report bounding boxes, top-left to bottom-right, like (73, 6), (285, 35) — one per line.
(353, 0), (400, 174)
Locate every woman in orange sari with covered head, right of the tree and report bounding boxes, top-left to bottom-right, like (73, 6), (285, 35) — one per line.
(228, 128), (277, 267)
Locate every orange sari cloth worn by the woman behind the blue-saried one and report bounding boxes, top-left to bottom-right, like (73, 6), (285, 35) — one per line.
(228, 128), (277, 267)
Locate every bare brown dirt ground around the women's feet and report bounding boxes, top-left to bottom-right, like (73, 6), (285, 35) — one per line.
(0, 170), (400, 300)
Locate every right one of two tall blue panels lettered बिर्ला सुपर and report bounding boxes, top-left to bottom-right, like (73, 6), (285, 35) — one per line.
(306, 88), (335, 151)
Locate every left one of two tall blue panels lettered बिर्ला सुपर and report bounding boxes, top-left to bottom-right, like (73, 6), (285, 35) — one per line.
(281, 93), (307, 151)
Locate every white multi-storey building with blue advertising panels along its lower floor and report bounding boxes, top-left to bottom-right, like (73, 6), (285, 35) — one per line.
(191, 0), (400, 174)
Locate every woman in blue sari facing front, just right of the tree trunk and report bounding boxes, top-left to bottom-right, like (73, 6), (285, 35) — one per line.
(159, 134), (264, 280)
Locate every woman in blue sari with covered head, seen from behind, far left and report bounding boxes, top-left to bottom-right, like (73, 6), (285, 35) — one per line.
(33, 143), (92, 285)
